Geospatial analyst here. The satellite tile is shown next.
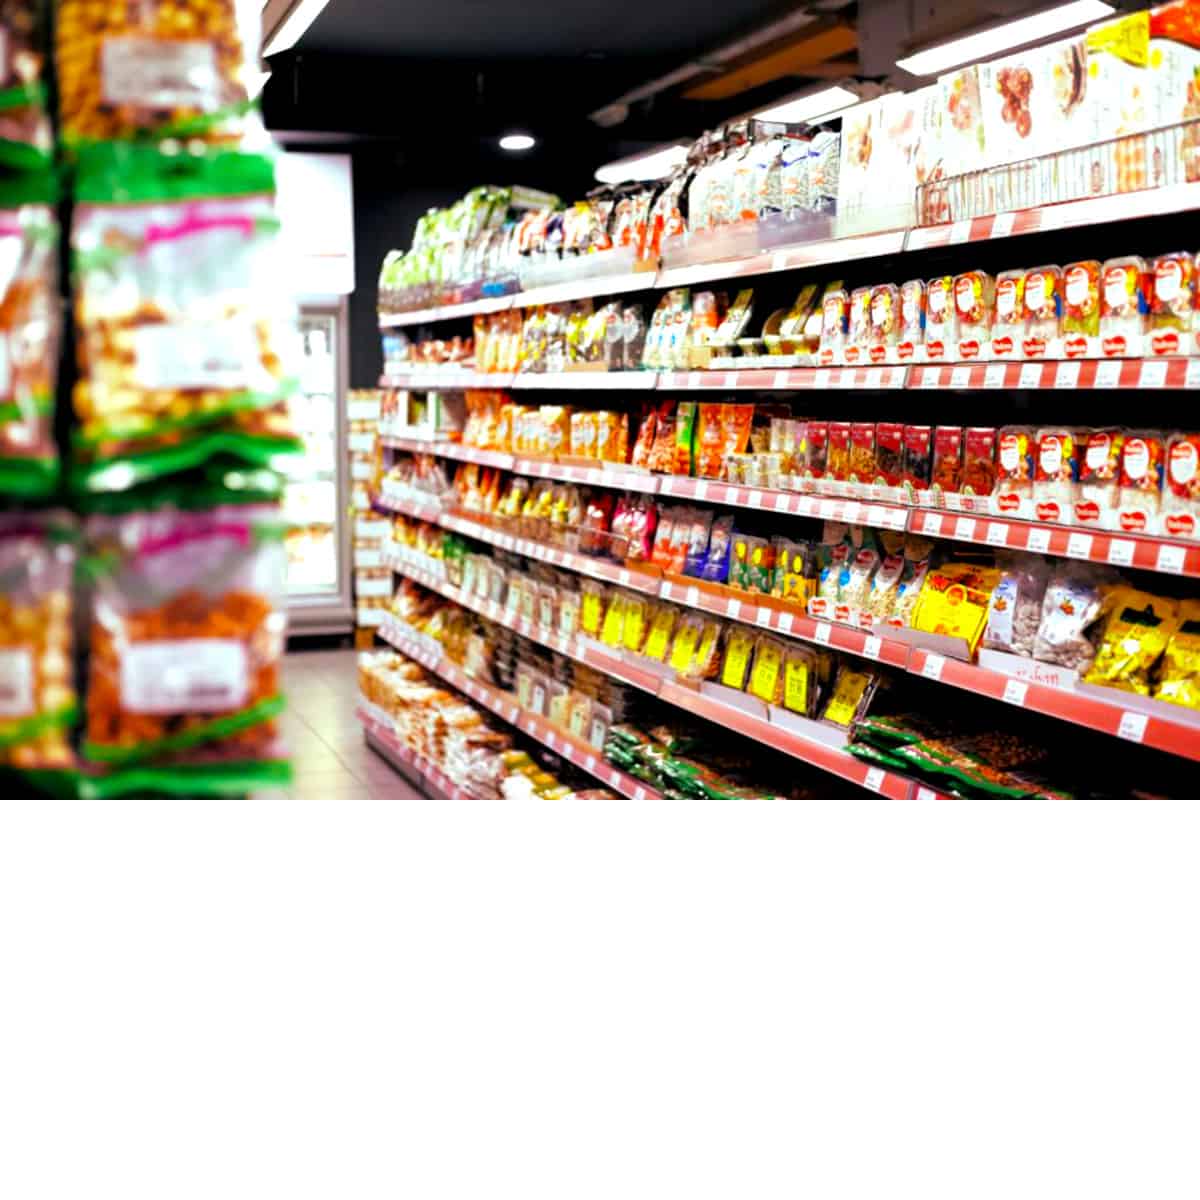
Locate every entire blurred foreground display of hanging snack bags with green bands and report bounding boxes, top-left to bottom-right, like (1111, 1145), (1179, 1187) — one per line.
(0, 9), (299, 796)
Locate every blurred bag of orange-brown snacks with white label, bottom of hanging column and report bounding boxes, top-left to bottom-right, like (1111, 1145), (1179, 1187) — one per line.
(84, 485), (287, 786)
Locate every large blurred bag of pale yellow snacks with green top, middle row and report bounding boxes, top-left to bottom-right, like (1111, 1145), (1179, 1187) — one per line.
(72, 144), (299, 491)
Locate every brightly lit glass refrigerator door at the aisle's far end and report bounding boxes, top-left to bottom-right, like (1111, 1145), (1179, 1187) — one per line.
(283, 300), (354, 636)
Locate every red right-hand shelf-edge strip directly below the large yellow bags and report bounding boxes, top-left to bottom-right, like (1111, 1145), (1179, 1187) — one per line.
(908, 648), (1200, 762)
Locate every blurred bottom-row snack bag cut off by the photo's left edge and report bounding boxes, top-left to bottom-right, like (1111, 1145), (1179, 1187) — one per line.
(0, 512), (76, 770)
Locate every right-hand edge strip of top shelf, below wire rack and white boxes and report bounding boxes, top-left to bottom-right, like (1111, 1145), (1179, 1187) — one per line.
(904, 177), (1200, 251)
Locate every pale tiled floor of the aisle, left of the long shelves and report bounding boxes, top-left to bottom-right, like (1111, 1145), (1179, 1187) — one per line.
(276, 649), (420, 800)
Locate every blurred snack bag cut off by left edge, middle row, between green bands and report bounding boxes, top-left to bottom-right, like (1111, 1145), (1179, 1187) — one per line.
(0, 175), (60, 497)
